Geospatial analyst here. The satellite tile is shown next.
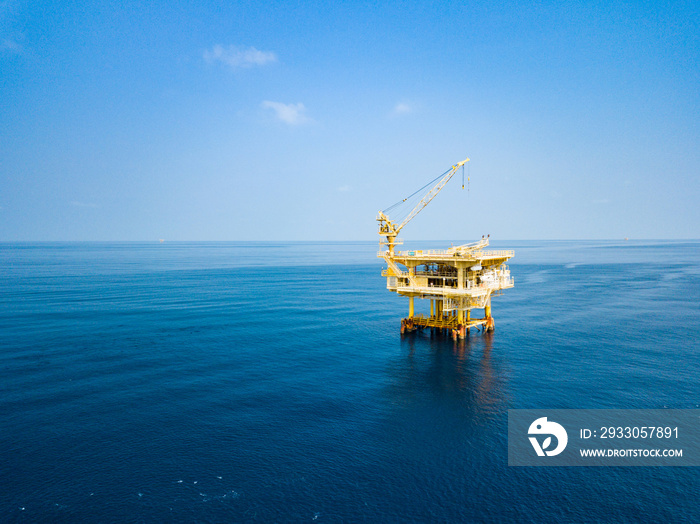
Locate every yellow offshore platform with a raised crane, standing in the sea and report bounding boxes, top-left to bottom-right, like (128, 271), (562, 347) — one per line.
(377, 158), (515, 338)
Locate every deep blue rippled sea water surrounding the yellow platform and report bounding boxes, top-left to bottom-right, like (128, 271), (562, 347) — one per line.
(0, 241), (700, 522)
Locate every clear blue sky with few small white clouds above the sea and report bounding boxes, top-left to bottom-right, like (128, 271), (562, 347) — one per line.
(0, 0), (700, 241)
